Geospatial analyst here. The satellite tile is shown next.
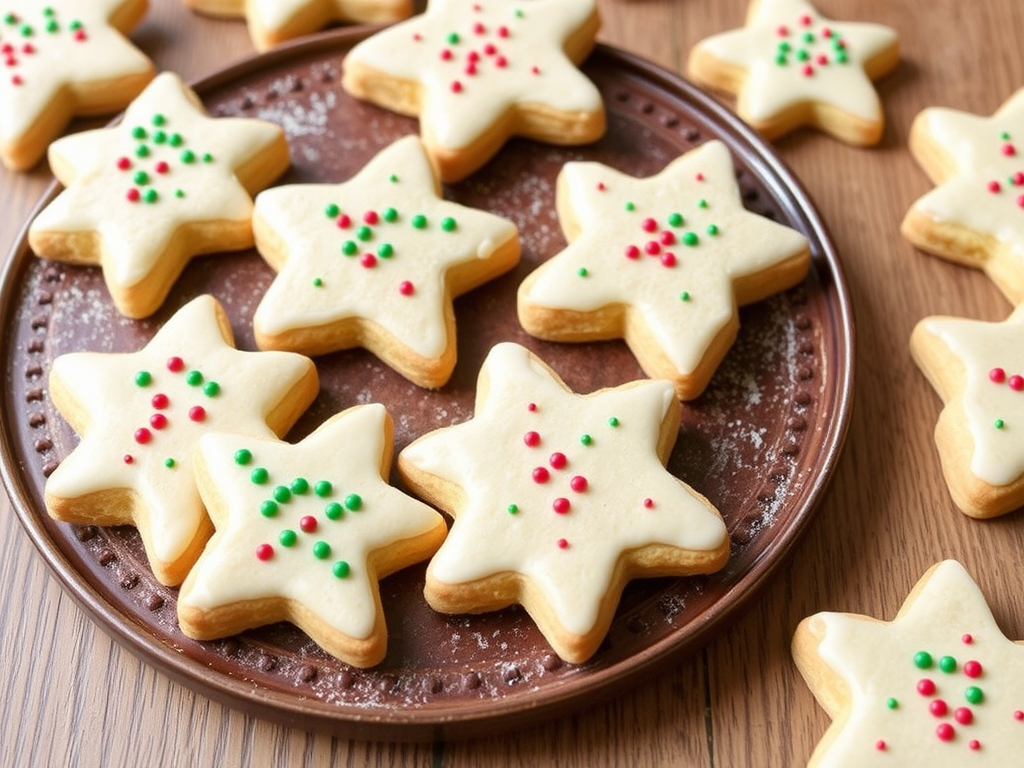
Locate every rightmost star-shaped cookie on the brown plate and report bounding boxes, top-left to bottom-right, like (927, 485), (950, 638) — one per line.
(518, 140), (810, 399)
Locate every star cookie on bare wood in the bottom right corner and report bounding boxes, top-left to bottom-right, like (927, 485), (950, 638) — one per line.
(793, 560), (1024, 768)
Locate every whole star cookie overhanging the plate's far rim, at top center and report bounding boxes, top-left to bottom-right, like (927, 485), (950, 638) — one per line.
(342, 0), (605, 181)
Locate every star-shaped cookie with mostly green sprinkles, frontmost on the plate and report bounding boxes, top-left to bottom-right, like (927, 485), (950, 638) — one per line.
(178, 403), (446, 667)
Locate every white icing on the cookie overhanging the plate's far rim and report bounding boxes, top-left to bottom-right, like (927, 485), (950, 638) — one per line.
(346, 0), (603, 150)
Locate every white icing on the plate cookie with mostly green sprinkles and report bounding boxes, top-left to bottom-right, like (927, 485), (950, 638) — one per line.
(178, 403), (441, 645)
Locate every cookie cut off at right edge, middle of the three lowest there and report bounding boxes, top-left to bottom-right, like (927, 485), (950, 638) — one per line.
(910, 305), (1024, 517)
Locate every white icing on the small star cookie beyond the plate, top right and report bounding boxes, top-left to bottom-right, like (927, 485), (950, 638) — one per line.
(698, 0), (896, 121)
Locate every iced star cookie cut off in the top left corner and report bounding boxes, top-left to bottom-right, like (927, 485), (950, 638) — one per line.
(0, 0), (155, 170)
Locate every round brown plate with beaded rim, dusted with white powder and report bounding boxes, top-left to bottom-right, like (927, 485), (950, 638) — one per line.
(0, 29), (853, 739)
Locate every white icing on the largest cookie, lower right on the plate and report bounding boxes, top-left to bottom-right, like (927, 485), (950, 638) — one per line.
(400, 342), (726, 635)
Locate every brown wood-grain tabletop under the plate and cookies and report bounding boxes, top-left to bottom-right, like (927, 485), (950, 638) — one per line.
(0, 0), (1024, 768)
